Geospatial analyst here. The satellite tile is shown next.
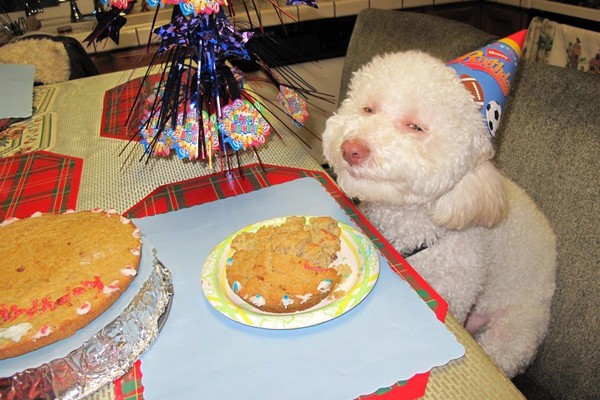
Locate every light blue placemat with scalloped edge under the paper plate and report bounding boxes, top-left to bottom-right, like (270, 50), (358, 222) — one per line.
(135, 178), (464, 400)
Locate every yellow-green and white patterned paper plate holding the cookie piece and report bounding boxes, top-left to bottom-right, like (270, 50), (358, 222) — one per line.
(201, 217), (379, 329)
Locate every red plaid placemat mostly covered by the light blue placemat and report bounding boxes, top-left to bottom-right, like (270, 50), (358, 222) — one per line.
(124, 164), (448, 400)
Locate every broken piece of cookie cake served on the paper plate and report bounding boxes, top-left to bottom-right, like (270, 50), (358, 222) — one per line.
(226, 217), (341, 313)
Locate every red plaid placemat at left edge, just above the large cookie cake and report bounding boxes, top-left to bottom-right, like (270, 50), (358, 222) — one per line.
(0, 151), (83, 221)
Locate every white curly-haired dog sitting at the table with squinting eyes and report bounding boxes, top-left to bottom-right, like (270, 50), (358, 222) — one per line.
(323, 51), (557, 377)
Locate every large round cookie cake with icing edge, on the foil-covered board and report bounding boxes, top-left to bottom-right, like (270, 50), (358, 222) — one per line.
(0, 210), (141, 359)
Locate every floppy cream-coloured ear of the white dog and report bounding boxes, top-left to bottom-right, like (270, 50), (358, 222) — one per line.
(432, 161), (507, 229)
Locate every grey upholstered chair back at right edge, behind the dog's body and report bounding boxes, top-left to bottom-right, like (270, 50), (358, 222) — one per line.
(496, 62), (600, 399)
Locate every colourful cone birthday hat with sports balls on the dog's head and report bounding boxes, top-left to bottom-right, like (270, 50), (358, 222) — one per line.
(447, 29), (527, 141)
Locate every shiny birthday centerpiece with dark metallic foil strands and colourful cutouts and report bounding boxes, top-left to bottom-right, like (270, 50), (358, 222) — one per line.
(86, 0), (322, 169)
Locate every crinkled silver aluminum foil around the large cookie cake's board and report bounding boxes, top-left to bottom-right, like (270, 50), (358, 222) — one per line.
(0, 258), (173, 400)
